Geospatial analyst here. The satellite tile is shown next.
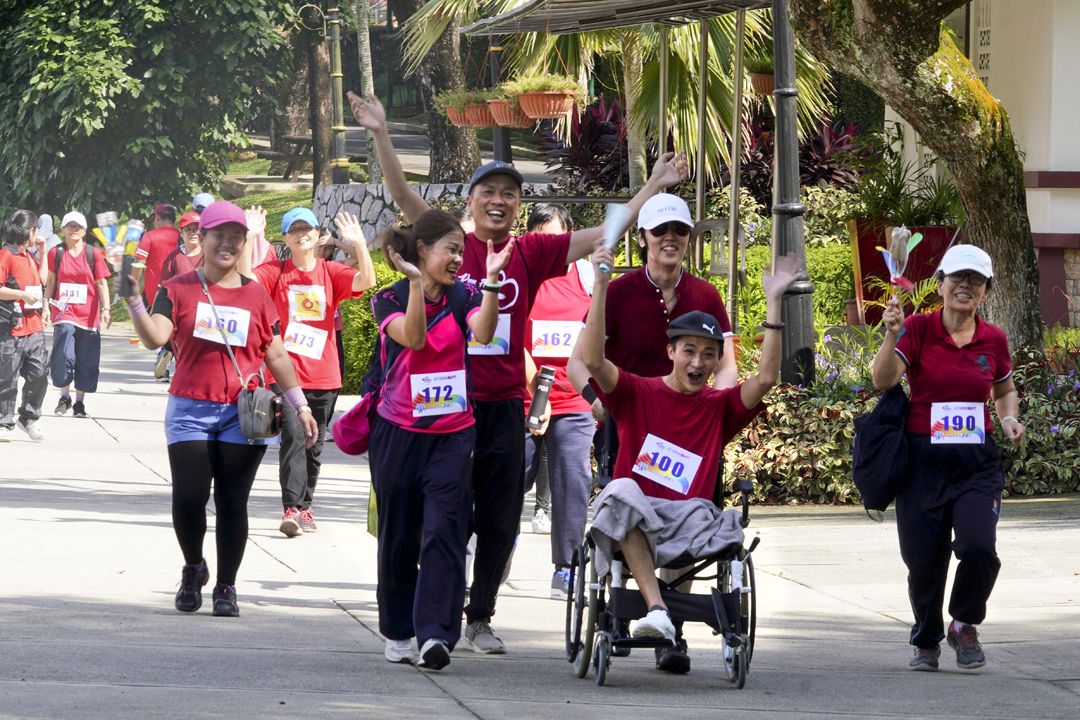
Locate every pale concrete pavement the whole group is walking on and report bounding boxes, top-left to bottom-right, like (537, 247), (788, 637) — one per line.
(0, 328), (1080, 720)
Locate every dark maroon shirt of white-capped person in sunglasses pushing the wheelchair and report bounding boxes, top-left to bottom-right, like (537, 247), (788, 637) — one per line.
(605, 268), (731, 378)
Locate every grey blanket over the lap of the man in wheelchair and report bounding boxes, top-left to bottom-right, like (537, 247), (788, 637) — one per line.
(590, 478), (743, 578)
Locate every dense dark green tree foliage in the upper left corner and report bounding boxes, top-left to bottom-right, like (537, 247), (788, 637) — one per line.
(0, 0), (292, 219)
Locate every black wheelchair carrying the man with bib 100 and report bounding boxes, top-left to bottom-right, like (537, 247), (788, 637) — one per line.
(566, 480), (760, 689)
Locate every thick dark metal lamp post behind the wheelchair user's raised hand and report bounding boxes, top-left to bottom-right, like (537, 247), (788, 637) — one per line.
(772, 0), (816, 385)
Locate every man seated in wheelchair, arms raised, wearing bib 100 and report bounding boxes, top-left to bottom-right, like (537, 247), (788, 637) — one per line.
(579, 248), (802, 669)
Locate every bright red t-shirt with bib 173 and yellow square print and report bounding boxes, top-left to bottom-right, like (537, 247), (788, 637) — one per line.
(255, 258), (363, 390)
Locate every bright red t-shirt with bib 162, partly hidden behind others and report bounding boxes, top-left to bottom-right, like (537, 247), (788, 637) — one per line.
(525, 263), (592, 416)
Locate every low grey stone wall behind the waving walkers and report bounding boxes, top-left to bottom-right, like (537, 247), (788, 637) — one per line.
(313, 182), (550, 241)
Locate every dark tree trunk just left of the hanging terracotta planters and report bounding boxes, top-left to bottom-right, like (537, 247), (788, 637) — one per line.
(397, 0), (481, 182)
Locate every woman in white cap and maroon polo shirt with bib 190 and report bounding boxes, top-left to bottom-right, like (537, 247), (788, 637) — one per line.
(874, 245), (1024, 670)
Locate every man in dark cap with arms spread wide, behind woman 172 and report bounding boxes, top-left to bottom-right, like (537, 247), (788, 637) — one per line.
(349, 93), (688, 653)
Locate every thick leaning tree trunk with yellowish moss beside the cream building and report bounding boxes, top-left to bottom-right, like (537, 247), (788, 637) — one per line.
(791, 0), (1042, 348)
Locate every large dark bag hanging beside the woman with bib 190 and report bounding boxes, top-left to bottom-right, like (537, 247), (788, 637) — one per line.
(851, 382), (909, 511)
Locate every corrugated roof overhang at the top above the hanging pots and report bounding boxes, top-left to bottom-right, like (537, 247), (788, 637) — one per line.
(462, 0), (772, 35)
